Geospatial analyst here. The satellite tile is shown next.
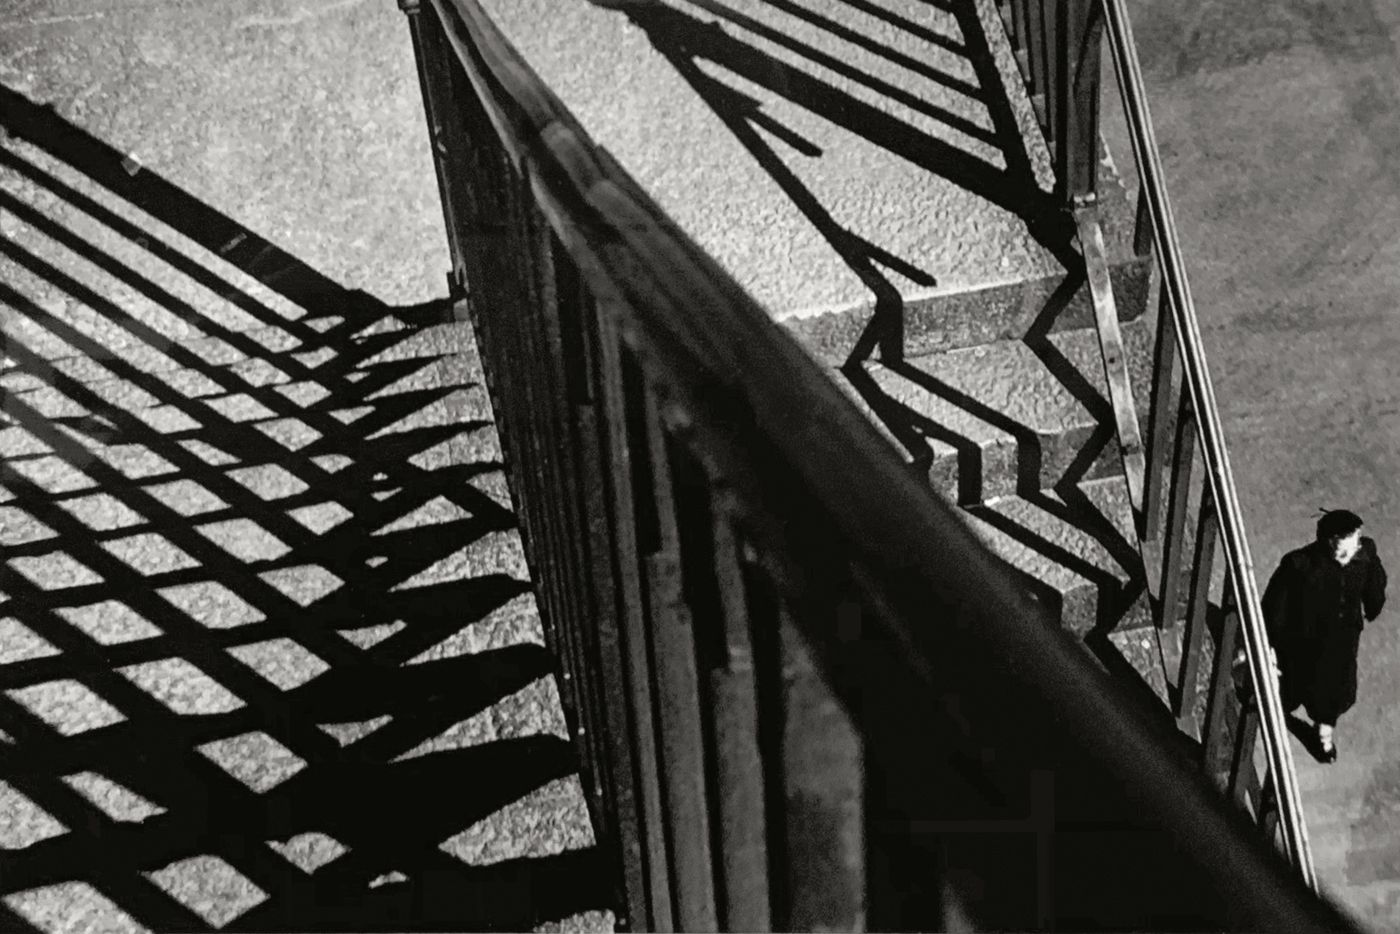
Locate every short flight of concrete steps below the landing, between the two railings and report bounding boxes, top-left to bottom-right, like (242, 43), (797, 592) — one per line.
(784, 175), (1180, 716)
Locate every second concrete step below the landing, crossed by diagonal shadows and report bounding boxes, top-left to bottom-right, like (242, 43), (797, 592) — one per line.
(966, 476), (1152, 637)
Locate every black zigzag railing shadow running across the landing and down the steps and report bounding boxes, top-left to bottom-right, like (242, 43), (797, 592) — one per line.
(592, 0), (1138, 627)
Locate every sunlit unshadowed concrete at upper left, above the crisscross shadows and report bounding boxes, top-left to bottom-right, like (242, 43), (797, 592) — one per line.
(0, 0), (447, 304)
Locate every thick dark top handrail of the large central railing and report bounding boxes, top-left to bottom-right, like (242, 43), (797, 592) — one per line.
(400, 0), (1345, 930)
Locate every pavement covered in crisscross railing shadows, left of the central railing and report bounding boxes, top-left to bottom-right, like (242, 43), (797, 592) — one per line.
(0, 88), (612, 931)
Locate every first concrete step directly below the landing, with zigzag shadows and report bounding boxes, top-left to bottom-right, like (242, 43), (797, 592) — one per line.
(837, 319), (1155, 506)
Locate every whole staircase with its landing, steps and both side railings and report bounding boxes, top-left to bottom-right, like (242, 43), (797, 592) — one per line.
(403, 0), (1337, 930)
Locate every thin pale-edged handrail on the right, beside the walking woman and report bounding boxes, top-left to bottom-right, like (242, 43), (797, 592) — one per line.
(1103, 0), (1317, 891)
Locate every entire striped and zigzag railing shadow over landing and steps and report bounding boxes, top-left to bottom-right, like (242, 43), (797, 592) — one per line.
(576, 0), (1159, 672)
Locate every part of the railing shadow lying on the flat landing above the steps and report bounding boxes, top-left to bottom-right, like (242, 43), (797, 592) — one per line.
(592, 0), (1077, 360)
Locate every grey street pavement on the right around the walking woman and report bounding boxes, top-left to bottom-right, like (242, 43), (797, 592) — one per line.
(1113, 0), (1400, 931)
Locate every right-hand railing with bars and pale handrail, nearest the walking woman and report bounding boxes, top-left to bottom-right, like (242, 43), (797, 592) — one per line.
(1002, 0), (1317, 889)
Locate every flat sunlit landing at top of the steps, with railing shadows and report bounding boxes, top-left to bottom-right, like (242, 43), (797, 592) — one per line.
(484, 0), (1060, 316)
